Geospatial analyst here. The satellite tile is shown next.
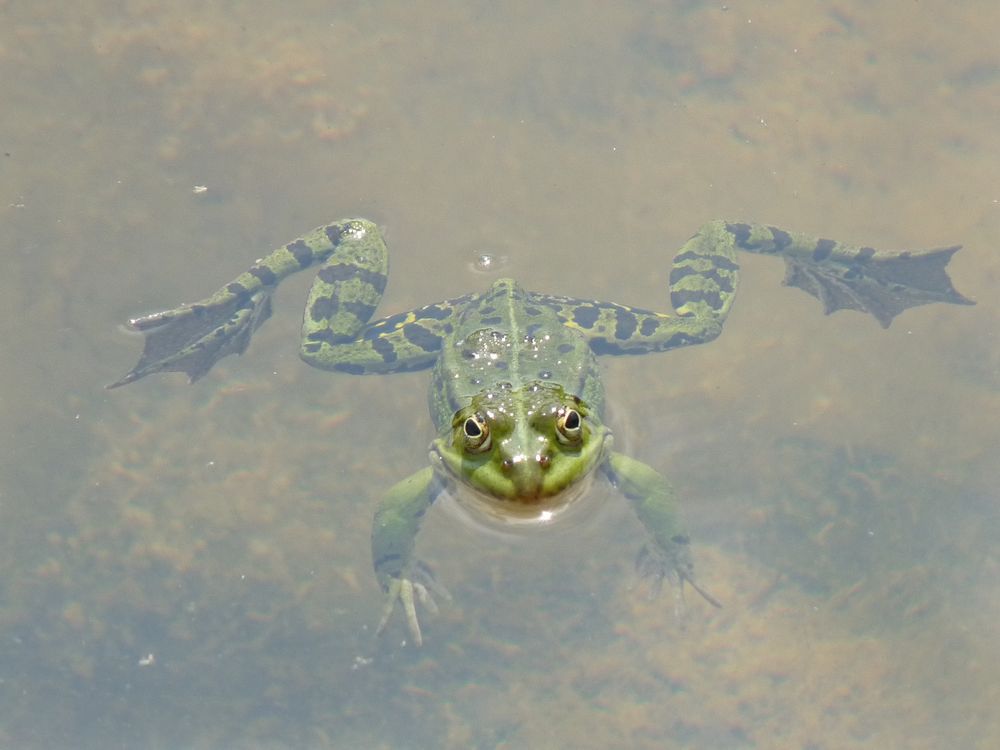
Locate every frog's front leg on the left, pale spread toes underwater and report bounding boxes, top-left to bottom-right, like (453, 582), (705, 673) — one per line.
(372, 467), (448, 646)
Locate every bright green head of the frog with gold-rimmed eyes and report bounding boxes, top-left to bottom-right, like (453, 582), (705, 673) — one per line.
(431, 381), (610, 507)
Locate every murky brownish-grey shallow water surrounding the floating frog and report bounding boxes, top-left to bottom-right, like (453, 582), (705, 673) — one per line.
(0, 0), (1000, 748)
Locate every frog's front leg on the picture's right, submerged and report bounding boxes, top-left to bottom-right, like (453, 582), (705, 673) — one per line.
(604, 452), (722, 607)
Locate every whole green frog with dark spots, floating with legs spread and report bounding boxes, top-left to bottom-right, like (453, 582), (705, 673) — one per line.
(108, 218), (974, 646)
